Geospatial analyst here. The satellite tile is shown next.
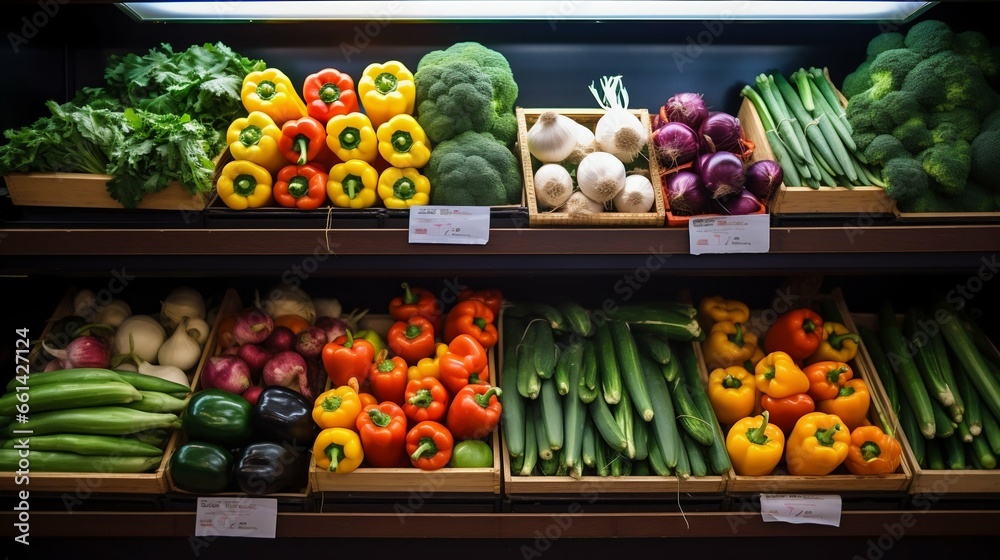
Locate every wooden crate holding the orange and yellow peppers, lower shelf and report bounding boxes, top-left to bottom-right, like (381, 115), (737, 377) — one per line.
(698, 290), (913, 499)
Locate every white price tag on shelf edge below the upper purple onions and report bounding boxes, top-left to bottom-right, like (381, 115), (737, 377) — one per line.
(688, 214), (771, 255)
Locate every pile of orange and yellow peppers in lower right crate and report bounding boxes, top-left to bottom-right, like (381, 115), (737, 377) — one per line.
(699, 296), (902, 476)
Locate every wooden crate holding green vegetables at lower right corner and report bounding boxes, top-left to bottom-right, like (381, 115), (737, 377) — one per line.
(851, 313), (1000, 501)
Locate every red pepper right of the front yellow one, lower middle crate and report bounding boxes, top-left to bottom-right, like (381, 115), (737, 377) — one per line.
(355, 401), (409, 468)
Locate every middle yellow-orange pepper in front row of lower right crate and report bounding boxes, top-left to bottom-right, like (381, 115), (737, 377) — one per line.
(785, 412), (851, 476)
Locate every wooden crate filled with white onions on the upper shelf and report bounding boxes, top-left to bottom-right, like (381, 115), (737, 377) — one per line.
(516, 78), (666, 227)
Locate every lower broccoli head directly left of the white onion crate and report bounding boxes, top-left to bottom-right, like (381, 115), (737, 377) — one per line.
(423, 130), (522, 206)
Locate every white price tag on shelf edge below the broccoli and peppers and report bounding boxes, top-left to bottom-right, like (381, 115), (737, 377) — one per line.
(409, 206), (490, 245)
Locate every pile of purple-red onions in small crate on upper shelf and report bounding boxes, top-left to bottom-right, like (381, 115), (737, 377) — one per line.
(650, 92), (782, 226)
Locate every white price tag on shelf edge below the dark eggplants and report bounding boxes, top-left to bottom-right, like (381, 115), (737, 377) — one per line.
(194, 497), (278, 539)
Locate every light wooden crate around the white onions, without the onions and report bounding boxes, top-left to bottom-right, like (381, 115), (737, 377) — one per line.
(515, 107), (666, 227)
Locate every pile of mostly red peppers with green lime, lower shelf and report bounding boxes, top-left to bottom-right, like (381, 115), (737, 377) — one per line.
(312, 283), (502, 474)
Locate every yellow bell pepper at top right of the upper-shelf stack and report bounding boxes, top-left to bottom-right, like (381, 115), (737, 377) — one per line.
(358, 60), (417, 129)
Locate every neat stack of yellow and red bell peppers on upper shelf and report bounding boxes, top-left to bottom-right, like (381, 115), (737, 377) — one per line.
(216, 60), (430, 210)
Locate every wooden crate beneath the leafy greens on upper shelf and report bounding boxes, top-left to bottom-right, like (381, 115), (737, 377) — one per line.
(4, 173), (210, 211)
